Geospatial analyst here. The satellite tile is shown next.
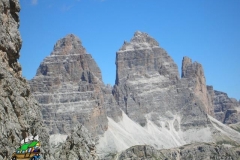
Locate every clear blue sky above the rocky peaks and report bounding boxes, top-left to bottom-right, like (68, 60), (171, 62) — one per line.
(20, 0), (240, 100)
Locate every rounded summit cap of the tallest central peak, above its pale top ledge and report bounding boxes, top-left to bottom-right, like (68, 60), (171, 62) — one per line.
(120, 31), (159, 51)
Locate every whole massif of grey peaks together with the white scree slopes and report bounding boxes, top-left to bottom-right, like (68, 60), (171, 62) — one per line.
(29, 32), (240, 159)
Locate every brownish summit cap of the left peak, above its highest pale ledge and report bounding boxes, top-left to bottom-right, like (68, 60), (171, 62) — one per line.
(51, 34), (86, 55)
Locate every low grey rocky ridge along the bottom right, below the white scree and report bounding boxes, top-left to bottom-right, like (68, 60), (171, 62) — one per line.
(116, 143), (240, 160)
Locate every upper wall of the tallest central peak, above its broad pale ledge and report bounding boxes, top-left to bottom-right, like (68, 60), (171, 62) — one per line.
(116, 32), (178, 85)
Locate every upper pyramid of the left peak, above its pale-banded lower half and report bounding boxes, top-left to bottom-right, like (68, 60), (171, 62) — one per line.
(32, 34), (102, 87)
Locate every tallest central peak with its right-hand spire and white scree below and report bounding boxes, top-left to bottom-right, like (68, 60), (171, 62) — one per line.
(97, 32), (240, 159)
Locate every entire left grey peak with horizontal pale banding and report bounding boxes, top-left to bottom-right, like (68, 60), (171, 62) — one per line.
(29, 35), (107, 135)
